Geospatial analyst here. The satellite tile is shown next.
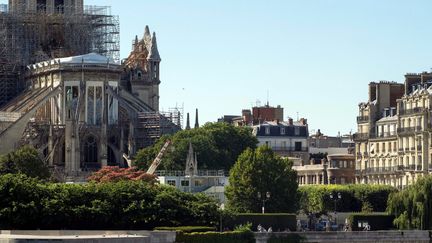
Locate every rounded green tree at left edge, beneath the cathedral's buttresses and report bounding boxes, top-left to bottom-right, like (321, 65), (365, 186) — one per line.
(0, 146), (50, 179)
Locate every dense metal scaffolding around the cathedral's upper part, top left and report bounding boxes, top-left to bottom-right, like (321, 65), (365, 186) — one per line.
(0, 1), (120, 107)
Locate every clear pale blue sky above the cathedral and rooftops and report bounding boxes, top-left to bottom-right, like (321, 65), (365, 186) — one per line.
(0, 0), (432, 135)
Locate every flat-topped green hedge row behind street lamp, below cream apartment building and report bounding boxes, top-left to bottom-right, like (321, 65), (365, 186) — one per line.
(299, 184), (396, 213)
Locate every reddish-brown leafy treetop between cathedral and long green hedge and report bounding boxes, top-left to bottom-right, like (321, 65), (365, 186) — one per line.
(88, 166), (157, 184)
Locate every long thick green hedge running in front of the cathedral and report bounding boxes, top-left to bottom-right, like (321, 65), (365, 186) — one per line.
(0, 174), (219, 230)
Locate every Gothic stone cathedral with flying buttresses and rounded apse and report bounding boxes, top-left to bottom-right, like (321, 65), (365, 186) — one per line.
(0, 0), (181, 178)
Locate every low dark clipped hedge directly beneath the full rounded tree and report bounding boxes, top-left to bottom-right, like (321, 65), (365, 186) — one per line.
(224, 213), (297, 231)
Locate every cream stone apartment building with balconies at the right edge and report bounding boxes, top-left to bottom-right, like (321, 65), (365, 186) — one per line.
(354, 72), (432, 188)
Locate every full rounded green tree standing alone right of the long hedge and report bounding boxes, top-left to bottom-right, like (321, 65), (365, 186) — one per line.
(225, 146), (298, 213)
